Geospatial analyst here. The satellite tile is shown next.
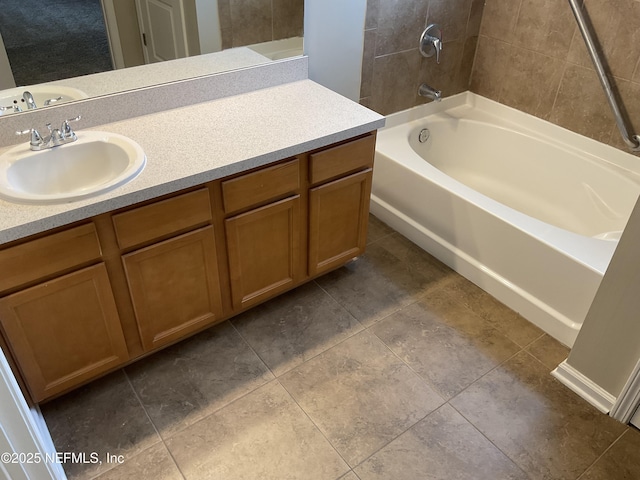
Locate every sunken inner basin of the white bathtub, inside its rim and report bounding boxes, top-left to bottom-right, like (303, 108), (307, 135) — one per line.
(410, 119), (640, 239)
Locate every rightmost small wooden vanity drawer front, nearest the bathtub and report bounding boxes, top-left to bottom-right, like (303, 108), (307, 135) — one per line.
(309, 134), (376, 184)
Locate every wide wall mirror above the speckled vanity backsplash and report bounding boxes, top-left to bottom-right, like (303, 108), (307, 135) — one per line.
(0, 0), (304, 114)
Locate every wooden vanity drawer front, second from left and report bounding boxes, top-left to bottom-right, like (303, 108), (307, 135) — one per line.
(113, 188), (211, 249)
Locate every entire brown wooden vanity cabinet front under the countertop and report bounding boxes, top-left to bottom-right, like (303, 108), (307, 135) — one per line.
(0, 133), (375, 402)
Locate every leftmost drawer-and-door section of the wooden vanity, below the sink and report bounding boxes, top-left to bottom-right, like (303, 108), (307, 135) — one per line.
(0, 224), (129, 402)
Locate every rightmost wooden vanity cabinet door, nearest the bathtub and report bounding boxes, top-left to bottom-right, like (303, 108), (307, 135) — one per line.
(309, 169), (372, 276)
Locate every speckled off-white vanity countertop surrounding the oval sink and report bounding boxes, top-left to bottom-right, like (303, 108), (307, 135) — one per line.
(0, 80), (384, 244)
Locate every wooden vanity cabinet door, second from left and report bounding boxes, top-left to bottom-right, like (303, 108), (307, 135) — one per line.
(122, 226), (222, 351)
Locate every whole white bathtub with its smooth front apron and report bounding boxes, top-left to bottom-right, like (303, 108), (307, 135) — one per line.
(371, 92), (640, 346)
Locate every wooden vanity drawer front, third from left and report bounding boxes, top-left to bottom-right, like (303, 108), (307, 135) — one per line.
(222, 160), (300, 213)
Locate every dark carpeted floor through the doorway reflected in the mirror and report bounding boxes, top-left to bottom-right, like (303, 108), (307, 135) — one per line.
(0, 0), (113, 85)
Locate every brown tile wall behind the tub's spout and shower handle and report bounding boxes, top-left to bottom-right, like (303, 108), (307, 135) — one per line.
(360, 0), (484, 115)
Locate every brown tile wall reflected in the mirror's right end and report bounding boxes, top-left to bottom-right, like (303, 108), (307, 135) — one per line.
(218, 0), (304, 48)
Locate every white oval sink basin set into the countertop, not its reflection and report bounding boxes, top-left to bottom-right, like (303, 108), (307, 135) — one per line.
(0, 131), (146, 204)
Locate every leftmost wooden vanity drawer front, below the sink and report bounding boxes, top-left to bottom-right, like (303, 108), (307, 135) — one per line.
(0, 223), (102, 292)
